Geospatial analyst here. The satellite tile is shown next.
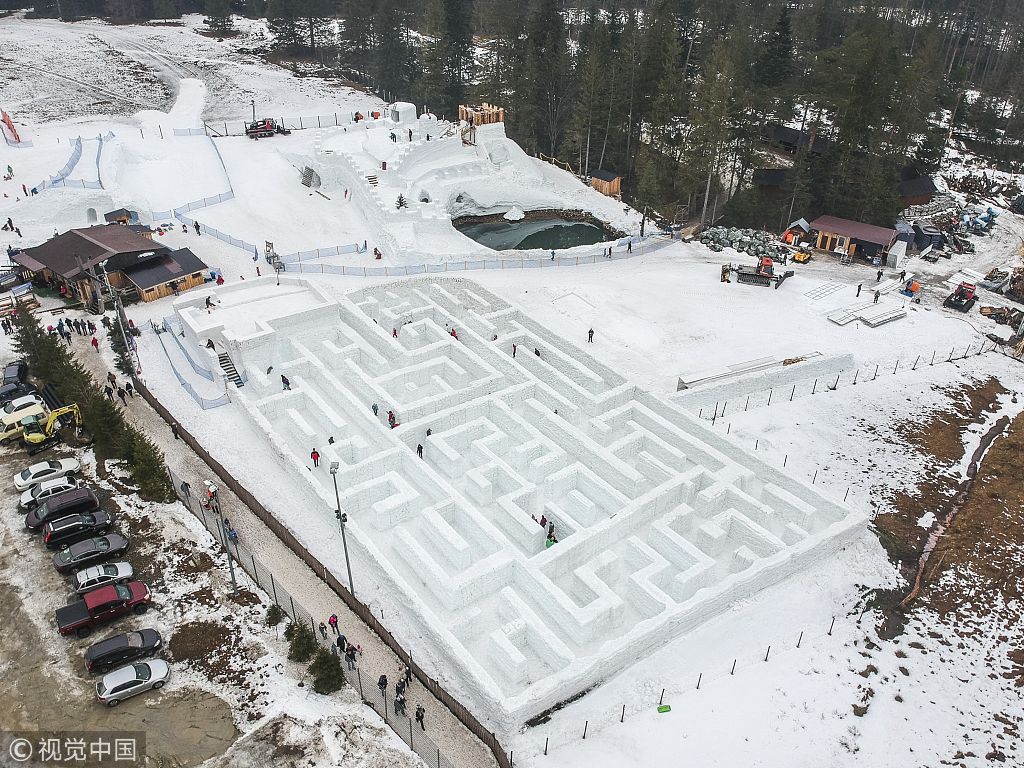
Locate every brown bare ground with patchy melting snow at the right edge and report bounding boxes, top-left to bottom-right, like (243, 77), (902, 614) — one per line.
(853, 379), (1024, 766)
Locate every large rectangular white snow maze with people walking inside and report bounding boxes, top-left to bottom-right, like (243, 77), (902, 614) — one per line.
(175, 279), (864, 726)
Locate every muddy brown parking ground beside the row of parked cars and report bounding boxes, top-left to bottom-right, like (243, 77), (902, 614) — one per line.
(0, 453), (238, 768)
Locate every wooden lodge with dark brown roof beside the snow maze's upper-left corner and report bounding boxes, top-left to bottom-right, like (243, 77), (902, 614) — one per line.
(11, 224), (207, 305)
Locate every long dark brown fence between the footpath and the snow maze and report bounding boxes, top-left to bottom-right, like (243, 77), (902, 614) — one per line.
(133, 377), (512, 768)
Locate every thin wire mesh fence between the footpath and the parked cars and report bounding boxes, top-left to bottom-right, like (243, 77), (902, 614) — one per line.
(167, 462), (456, 768)
